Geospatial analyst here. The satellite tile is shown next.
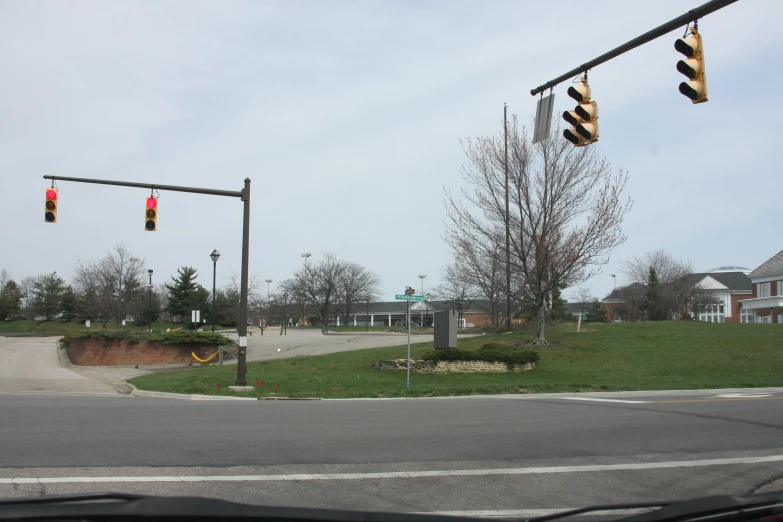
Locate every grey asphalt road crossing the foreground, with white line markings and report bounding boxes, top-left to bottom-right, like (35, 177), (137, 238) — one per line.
(0, 393), (783, 516)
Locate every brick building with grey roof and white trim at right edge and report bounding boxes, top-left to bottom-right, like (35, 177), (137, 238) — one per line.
(740, 250), (783, 324)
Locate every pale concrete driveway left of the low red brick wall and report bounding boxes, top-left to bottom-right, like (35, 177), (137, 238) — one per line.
(0, 337), (117, 393)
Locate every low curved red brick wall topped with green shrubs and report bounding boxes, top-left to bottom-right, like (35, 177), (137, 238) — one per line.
(66, 339), (217, 366)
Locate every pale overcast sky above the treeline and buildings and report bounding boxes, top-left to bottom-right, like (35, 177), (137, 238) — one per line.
(0, 0), (783, 299)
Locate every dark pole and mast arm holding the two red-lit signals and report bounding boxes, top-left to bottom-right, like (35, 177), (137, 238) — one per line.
(44, 176), (250, 386)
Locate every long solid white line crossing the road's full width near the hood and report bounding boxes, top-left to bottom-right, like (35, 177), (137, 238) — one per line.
(0, 455), (783, 484)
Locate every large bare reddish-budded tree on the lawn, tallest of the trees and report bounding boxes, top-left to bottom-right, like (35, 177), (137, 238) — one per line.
(445, 116), (631, 344)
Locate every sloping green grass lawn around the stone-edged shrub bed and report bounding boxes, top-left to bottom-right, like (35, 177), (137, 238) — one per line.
(130, 322), (783, 398)
